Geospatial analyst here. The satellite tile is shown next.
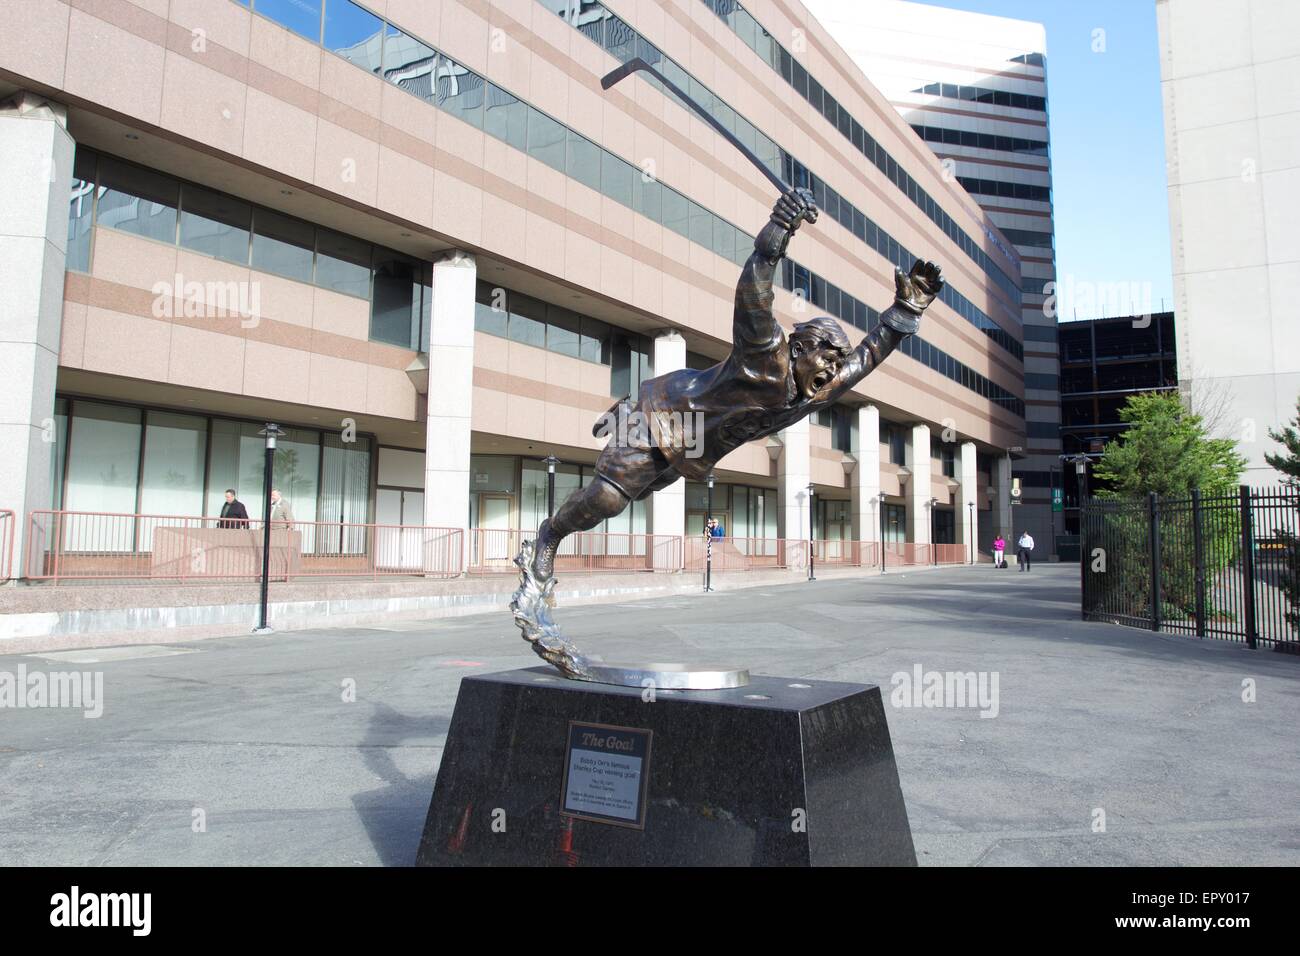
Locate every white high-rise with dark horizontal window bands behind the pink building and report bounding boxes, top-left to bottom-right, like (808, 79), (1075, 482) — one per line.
(807, 0), (1062, 553)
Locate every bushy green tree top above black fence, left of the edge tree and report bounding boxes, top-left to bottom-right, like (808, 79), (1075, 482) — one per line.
(1096, 392), (1245, 498)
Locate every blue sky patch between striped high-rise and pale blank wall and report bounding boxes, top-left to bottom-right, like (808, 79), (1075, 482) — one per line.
(920, 0), (1173, 319)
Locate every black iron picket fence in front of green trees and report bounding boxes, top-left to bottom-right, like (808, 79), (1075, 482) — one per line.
(1082, 485), (1300, 653)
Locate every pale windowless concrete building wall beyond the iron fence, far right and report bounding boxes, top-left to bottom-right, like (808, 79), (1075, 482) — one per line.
(1156, 0), (1300, 485)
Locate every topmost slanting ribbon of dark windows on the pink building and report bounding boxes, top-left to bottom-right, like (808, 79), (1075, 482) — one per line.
(702, 0), (1019, 295)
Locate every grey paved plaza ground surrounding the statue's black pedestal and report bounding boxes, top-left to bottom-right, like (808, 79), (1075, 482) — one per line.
(0, 566), (1300, 866)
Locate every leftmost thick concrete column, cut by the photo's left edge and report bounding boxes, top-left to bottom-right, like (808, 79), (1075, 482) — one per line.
(0, 92), (75, 576)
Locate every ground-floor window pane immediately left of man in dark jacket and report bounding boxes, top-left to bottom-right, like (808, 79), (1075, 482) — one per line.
(140, 411), (206, 515)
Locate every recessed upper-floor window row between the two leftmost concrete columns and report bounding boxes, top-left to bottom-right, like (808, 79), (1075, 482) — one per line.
(68, 147), (430, 350)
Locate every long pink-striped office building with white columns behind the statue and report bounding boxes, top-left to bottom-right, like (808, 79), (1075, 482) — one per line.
(0, 0), (1024, 582)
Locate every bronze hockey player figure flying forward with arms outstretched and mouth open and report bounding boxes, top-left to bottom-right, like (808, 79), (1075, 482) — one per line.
(511, 189), (943, 679)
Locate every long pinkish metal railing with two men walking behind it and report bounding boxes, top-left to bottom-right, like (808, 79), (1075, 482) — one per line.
(23, 511), (463, 584)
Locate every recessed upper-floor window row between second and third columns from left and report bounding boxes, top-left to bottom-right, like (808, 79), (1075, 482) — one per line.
(475, 280), (650, 397)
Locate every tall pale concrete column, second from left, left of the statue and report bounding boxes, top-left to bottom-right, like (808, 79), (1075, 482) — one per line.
(424, 250), (478, 572)
